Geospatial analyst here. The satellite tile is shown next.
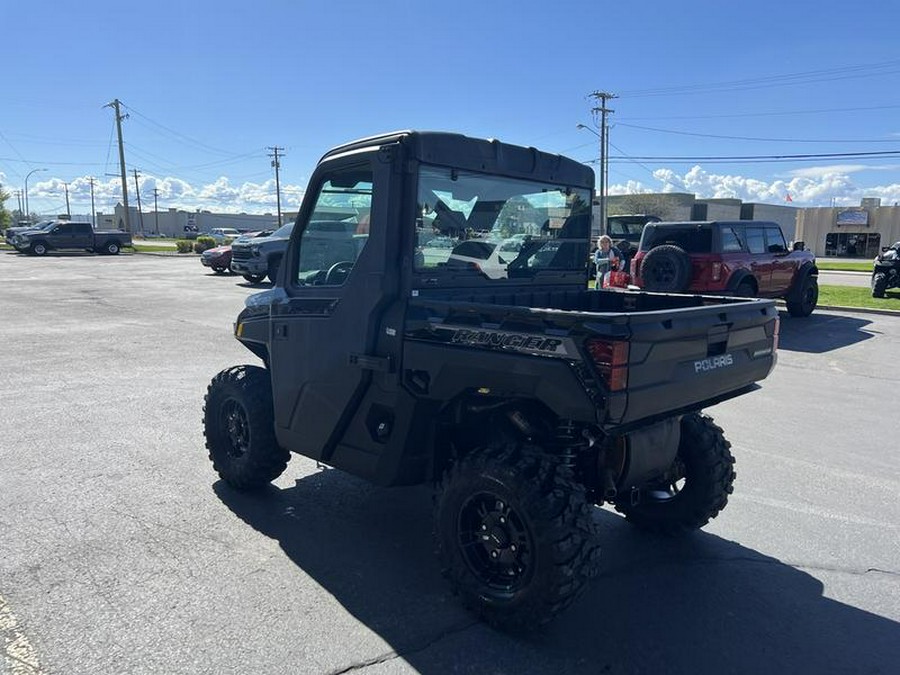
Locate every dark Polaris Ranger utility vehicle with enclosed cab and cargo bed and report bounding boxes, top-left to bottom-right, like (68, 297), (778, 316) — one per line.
(204, 132), (778, 628)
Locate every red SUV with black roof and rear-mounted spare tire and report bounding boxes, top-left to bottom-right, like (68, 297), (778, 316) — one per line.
(631, 220), (819, 316)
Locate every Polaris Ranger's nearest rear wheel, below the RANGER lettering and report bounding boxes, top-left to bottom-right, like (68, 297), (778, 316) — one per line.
(434, 444), (600, 629)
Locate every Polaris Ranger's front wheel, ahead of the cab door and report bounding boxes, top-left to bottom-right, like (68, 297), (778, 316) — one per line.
(203, 366), (290, 490)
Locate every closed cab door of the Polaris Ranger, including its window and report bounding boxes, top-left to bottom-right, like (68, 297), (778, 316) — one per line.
(269, 152), (398, 470)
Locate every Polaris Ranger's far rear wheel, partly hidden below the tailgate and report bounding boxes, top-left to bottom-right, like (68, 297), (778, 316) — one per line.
(616, 413), (737, 535)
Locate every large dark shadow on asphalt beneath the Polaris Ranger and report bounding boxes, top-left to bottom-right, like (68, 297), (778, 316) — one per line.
(213, 470), (900, 675)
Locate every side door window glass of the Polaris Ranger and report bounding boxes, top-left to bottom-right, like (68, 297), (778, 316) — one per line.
(296, 164), (373, 286)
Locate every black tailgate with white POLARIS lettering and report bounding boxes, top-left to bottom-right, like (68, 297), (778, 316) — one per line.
(602, 300), (778, 426)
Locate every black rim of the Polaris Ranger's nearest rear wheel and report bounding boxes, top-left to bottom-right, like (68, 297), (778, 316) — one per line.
(458, 492), (534, 593)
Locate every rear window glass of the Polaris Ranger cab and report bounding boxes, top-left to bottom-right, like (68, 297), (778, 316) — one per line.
(415, 165), (591, 280)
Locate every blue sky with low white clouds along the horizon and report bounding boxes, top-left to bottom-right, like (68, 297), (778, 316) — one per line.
(0, 0), (900, 214)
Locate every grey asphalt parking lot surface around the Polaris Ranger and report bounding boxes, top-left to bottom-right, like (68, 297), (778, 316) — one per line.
(0, 252), (900, 675)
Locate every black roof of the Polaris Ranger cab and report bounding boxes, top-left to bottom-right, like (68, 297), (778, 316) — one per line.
(322, 130), (594, 189)
